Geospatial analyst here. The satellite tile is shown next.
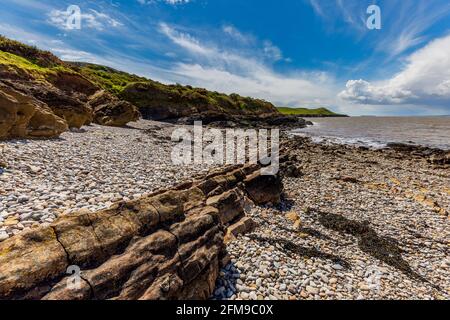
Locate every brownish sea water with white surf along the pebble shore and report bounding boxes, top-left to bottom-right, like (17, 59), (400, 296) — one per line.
(293, 116), (450, 150)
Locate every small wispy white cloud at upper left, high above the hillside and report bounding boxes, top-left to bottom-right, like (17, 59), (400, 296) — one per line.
(48, 9), (122, 31)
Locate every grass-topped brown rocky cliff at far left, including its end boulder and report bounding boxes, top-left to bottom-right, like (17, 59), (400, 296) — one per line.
(0, 37), (140, 138)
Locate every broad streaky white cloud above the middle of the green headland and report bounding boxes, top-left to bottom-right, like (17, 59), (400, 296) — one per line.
(160, 23), (337, 106)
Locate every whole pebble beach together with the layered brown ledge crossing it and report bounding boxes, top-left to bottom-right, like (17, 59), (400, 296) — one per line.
(0, 120), (450, 300)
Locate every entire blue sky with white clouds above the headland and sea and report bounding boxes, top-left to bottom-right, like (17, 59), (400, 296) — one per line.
(0, 0), (450, 116)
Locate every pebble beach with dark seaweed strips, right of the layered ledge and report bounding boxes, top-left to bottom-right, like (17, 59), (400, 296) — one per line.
(216, 134), (450, 300)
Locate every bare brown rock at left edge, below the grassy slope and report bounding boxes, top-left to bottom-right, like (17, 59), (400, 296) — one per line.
(0, 85), (68, 139)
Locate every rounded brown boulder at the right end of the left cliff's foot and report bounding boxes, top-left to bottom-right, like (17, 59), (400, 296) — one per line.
(89, 90), (141, 127)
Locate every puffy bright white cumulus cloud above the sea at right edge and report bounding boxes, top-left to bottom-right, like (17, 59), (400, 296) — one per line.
(339, 35), (450, 106)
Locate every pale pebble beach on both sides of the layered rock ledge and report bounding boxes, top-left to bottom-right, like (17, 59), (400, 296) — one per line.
(0, 121), (450, 300)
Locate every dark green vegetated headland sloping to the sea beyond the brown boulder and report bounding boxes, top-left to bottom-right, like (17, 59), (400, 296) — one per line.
(70, 63), (278, 119)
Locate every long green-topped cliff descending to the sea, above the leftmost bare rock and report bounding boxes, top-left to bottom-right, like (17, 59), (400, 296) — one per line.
(0, 36), (305, 138)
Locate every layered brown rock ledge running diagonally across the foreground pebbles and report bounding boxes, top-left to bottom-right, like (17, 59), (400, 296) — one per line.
(0, 166), (281, 300)
